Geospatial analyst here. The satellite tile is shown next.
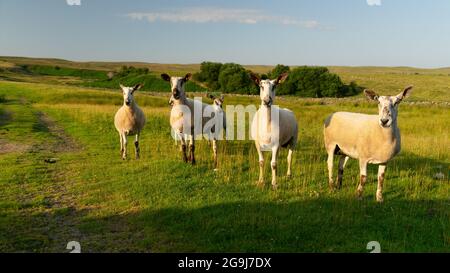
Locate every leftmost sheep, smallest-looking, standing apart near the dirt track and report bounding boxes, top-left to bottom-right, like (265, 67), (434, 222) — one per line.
(114, 84), (146, 160)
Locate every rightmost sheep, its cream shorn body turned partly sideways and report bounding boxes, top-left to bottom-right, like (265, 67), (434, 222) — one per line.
(323, 86), (413, 202)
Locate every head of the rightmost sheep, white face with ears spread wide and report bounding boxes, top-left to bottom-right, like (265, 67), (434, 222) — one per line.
(364, 86), (413, 128)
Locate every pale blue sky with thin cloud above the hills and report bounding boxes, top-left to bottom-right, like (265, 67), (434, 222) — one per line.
(0, 0), (450, 67)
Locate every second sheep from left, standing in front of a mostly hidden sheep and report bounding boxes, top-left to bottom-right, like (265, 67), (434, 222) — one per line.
(161, 73), (225, 169)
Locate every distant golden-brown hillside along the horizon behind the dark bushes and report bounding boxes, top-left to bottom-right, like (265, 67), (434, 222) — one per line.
(0, 56), (450, 101)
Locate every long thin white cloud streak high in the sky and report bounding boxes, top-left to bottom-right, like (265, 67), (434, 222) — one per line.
(126, 7), (321, 28)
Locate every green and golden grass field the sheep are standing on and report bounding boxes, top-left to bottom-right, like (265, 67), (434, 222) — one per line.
(0, 56), (450, 252)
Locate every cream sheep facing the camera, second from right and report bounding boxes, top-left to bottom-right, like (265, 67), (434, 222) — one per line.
(251, 73), (298, 190)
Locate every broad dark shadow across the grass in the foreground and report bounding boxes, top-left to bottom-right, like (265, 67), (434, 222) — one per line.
(0, 198), (450, 252)
